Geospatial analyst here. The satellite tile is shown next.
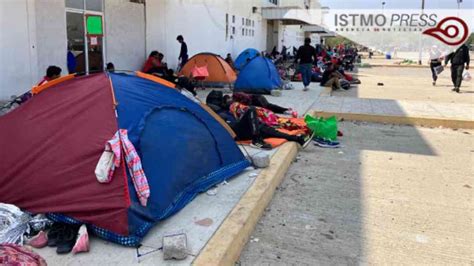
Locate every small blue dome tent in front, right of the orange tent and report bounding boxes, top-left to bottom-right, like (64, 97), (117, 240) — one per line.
(234, 55), (282, 94)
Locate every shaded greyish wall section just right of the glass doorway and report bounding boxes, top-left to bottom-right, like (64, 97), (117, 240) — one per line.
(104, 0), (146, 70)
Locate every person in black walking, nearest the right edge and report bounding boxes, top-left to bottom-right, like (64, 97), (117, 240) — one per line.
(444, 44), (471, 93)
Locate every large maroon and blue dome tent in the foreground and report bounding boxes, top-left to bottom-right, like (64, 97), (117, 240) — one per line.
(0, 73), (249, 246)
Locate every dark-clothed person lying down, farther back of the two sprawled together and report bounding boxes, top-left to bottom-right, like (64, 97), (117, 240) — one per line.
(231, 92), (298, 116)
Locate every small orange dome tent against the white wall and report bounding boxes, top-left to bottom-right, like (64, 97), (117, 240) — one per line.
(179, 53), (237, 83)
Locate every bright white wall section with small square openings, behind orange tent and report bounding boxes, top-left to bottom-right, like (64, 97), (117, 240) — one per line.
(146, 0), (267, 68)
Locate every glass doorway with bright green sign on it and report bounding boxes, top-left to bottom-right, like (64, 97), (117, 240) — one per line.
(65, 0), (105, 74)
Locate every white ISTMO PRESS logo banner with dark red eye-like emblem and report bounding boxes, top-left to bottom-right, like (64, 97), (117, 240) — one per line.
(323, 9), (473, 50)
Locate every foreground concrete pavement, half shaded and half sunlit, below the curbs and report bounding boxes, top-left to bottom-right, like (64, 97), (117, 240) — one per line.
(238, 122), (474, 265)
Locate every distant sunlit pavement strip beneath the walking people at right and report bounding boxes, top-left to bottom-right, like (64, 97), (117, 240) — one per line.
(333, 65), (474, 104)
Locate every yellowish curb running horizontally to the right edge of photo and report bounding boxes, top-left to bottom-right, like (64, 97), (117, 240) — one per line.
(312, 111), (474, 129)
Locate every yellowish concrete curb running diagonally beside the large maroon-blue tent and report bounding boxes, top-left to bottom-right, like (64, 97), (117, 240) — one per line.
(193, 142), (298, 266)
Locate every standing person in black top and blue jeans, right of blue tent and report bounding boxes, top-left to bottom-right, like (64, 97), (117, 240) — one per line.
(295, 38), (317, 91)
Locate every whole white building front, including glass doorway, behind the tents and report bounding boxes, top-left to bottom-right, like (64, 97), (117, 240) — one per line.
(0, 0), (319, 100)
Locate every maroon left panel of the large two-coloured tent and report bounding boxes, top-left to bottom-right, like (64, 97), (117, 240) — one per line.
(0, 75), (128, 235)
